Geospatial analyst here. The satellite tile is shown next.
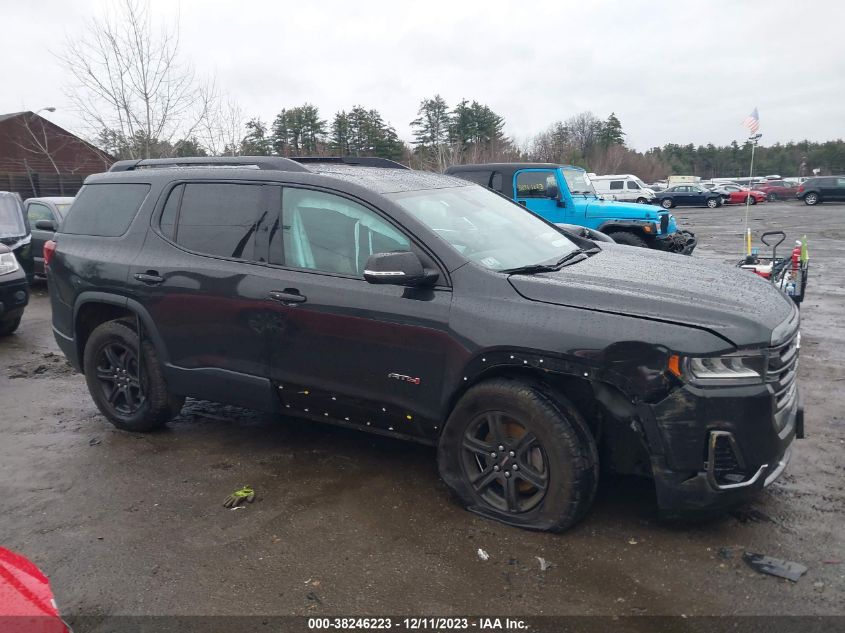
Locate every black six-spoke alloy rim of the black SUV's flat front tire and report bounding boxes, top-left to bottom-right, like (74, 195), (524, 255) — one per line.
(462, 411), (549, 514)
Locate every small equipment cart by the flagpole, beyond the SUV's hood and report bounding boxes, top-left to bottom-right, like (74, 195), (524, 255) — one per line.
(737, 230), (810, 307)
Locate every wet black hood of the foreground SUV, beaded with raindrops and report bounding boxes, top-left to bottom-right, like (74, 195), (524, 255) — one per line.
(509, 244), (796, 347)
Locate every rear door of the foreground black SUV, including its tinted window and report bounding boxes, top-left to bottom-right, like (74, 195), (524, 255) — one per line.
(128, 181), (276, 407)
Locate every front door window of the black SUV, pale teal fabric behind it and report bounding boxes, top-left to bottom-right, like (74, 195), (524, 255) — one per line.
(282, 188), (411, 277)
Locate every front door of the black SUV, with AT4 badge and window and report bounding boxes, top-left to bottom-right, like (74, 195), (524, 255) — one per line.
(266, 187), (457, 437)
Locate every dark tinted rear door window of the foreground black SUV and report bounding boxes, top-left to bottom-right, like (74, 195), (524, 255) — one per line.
(173, 183), (263, 260)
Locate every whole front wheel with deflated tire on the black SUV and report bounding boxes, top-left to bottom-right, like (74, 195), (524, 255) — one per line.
(437, 378), (599, 532)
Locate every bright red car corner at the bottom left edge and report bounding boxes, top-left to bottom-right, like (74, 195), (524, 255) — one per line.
(0, 547), (70, 633)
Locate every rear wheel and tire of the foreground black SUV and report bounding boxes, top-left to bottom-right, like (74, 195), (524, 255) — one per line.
(83, 321), (185, 432)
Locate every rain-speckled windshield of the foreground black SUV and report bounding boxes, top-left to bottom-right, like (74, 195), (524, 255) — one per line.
(387, 186), (577, 271)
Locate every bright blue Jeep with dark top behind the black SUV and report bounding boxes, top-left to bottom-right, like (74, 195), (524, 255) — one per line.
(446, 163), (696, 255)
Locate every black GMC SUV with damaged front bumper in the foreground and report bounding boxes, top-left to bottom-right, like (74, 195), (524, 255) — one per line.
(46, 157), (803, 530)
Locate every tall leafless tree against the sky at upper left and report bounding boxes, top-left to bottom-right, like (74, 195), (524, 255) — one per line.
(60, 0), (209, 158)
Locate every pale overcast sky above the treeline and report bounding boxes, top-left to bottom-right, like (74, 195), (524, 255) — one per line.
(0, 0), (845, 150)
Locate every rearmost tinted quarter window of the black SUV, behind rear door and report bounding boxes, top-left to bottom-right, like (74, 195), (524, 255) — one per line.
(61, 184), (150, 237)
